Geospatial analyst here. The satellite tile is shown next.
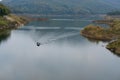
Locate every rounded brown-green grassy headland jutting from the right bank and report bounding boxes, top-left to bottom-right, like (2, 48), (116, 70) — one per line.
(81, 25), (114, 41)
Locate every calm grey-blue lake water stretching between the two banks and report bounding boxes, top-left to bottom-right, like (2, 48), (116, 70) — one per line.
(0, 16), (120, 80)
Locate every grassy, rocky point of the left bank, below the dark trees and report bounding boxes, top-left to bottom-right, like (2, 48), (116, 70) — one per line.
(0, 14), (29, 30)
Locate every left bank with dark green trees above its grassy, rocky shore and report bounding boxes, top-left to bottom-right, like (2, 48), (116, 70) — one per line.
(0, 4), (28, 30)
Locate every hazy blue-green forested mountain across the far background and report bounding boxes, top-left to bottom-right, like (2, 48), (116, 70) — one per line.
(2, 0), (120, 15)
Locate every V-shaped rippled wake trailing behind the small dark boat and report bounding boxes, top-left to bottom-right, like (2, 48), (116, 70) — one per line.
(29, 31), (80, 46)
